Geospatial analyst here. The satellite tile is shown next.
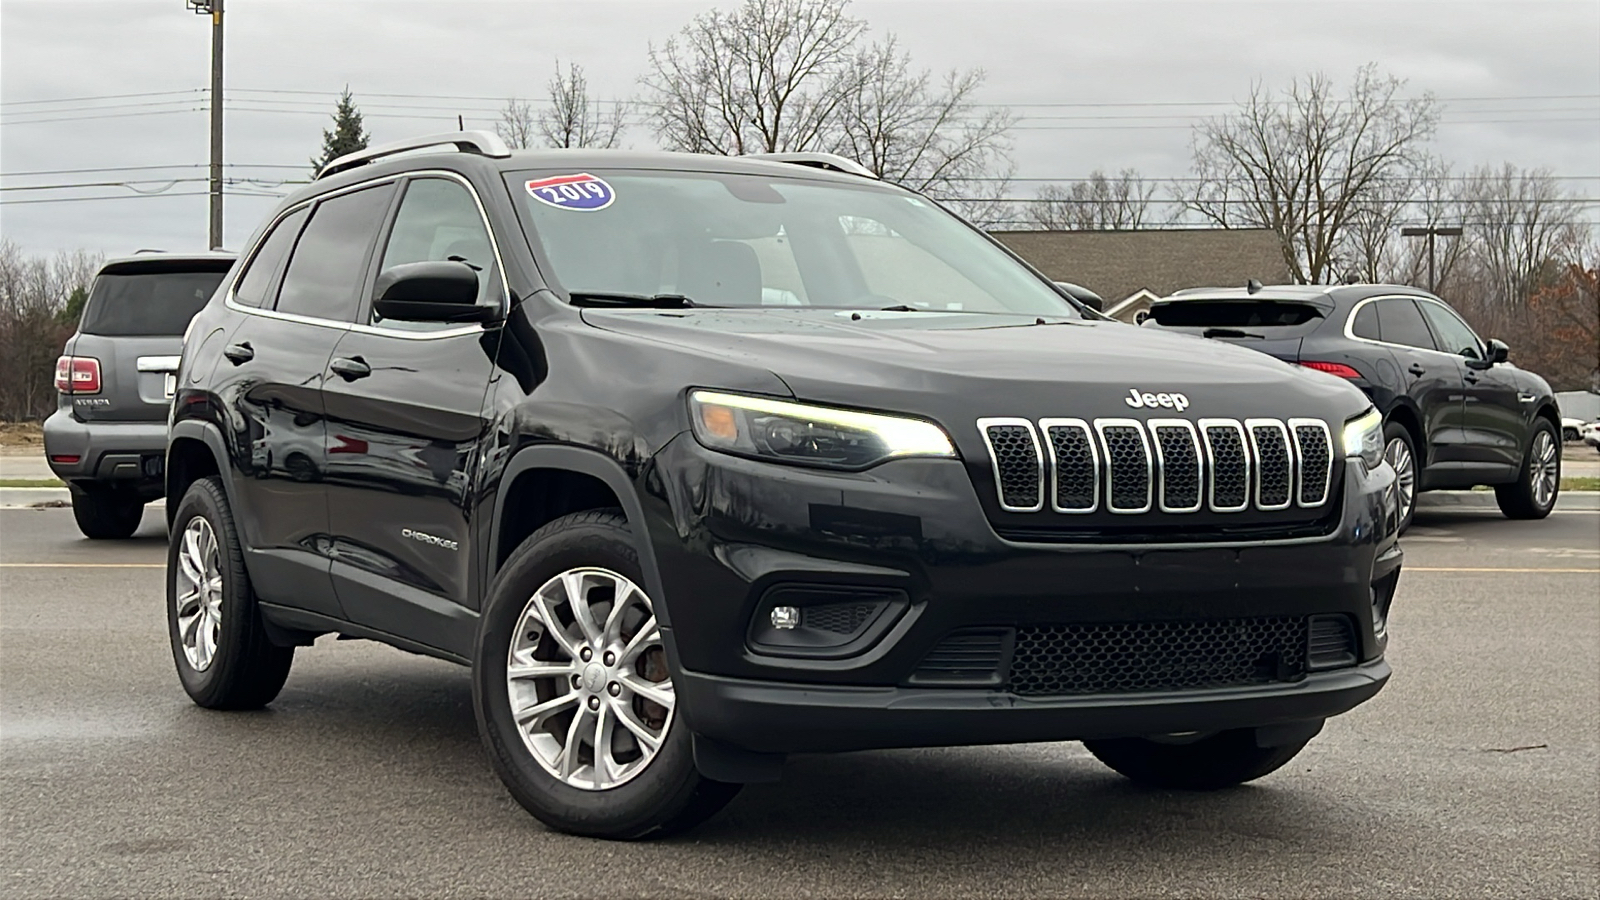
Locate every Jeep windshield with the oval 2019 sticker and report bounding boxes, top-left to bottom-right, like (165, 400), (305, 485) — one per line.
(507, 170), (1077, 315)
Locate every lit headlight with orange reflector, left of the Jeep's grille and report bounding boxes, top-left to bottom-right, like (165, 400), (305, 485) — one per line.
(690, 391), (955, 469)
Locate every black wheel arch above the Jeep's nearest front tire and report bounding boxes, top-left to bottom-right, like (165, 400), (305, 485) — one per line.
(483, 445), (672, 626)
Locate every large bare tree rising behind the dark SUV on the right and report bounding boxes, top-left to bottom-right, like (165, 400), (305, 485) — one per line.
(1178, 64), (1438, 283)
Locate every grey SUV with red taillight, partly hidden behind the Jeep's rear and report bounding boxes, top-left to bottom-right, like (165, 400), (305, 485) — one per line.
(45, 253), (234, 538)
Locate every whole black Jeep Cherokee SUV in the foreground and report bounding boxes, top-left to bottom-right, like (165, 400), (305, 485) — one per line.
(166, 133), (1400, 838)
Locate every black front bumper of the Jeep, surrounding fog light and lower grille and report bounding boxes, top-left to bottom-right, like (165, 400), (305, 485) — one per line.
(640, 436), (1402, 753)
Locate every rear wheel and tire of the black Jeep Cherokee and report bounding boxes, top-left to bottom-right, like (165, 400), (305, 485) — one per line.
(166, 476), (294, 709)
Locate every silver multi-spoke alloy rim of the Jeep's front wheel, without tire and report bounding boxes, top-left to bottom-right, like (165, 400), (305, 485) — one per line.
(506, 567), (675, 791)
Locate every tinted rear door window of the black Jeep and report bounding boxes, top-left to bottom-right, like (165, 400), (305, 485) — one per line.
(277, 184), (394, 322)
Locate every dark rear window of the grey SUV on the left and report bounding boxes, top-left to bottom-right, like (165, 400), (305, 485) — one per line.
(78, 263), (229, 336)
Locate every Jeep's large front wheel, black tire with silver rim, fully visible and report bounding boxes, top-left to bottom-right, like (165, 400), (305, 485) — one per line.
(472, 509), (739, 839)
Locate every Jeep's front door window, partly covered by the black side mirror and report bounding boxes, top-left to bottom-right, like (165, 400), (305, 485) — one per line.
(371, 178), (496, 331)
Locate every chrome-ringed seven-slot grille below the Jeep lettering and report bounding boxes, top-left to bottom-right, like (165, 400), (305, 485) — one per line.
(978, 418), (1333, 514)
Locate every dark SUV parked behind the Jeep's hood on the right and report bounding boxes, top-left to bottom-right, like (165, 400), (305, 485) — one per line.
(1144, 283), (1562, 528)
